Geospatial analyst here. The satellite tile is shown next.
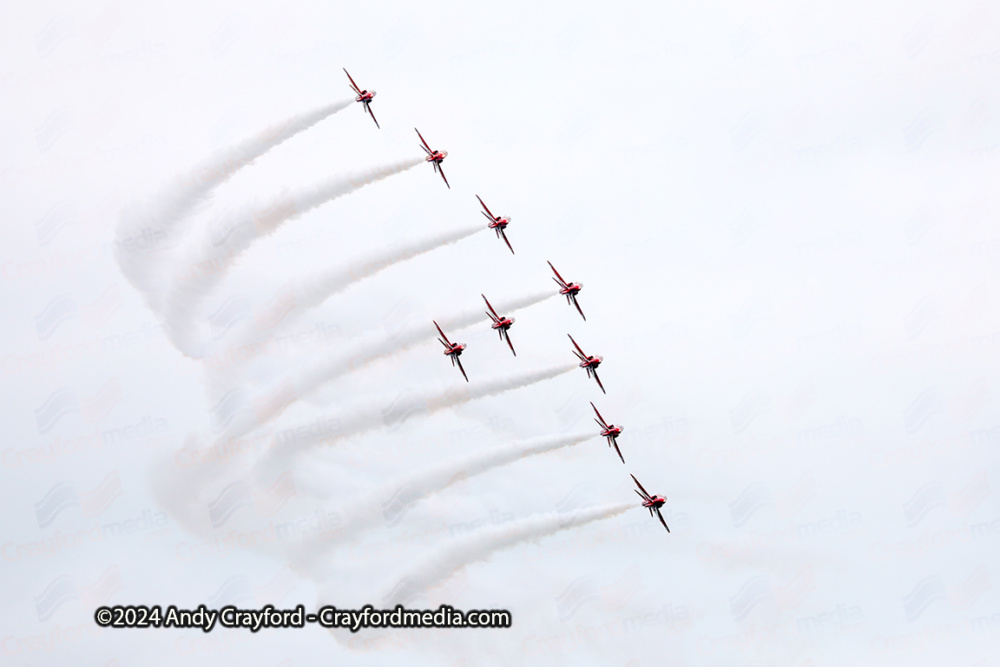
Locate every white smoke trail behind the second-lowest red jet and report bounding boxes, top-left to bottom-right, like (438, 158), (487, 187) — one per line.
(292, 433), (594, 581)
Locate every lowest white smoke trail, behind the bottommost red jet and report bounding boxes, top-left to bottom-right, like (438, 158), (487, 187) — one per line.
(320, 503), (637, 608)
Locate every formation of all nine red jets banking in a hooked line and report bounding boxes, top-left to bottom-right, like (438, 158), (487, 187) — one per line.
(344, 68), (670, 533)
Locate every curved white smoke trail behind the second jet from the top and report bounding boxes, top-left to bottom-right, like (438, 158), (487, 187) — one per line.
(163, 158), (424, 358)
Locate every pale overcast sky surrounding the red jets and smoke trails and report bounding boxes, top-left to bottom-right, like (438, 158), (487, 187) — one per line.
(0, 2), (1000, 665)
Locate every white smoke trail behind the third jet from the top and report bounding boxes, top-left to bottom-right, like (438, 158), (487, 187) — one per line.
(231, 225), (486, 349)
